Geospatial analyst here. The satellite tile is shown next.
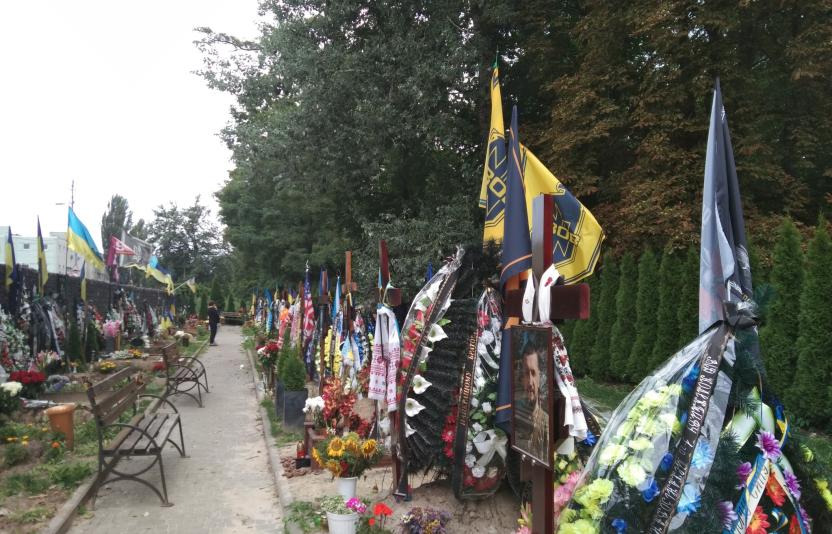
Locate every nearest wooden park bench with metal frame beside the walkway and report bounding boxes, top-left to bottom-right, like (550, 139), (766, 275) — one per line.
(87, 366), (186, 506)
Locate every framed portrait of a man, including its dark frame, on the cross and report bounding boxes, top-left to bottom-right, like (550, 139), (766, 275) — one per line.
(511, 325), (555, 469)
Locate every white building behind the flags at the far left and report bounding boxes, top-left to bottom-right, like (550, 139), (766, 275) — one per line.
(0, 226), (109, 281)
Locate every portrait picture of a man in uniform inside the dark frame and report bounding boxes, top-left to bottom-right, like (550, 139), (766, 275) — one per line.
(511, 330), (551, 465)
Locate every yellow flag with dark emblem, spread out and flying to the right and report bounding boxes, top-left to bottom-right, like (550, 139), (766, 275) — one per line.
(520, 147), (604, 284)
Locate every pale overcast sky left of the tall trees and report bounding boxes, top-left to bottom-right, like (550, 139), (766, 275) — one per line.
(0, 0), (258, 247)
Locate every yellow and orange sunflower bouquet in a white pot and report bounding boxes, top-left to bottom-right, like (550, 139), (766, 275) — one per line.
(312, 432), (384, 478)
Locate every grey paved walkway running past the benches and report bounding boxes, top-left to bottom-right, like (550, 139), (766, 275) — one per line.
(70, 326), (283, 534)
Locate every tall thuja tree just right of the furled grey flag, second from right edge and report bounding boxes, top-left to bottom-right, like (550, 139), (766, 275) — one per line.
(760, 218), (804, 395)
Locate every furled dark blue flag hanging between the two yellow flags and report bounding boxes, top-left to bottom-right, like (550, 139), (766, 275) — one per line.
(500, 106), (532, 288)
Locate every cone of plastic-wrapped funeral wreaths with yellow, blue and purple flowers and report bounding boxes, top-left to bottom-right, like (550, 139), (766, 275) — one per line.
(557, 325), (832, 534)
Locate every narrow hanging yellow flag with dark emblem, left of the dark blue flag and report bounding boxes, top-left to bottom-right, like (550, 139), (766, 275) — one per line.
(479, 62), (508, 243)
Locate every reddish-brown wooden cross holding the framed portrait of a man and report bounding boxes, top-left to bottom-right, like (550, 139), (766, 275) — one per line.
(504, 195), (590, 534)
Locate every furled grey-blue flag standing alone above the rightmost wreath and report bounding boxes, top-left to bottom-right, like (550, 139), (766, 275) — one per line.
(699, 79), (753, 333)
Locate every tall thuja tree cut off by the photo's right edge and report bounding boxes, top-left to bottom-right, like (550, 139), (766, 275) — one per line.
(787, 219), (832, 426)
